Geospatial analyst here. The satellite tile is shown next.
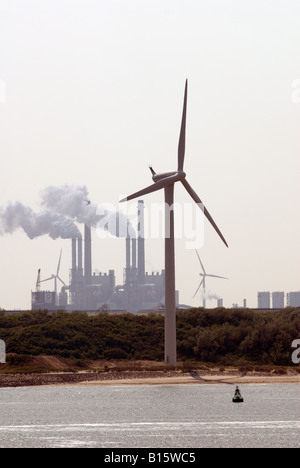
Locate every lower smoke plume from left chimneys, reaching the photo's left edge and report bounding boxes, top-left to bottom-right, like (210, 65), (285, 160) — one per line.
(0, 202), (81, 239)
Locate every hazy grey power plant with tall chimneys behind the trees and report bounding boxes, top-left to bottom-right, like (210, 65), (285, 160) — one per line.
(31, 200), (172, 313)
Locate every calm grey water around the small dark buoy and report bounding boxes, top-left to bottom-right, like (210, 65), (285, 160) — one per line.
(0, 385), (300, 448)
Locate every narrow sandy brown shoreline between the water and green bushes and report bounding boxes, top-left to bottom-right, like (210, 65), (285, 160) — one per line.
(0, 370), (300, 389)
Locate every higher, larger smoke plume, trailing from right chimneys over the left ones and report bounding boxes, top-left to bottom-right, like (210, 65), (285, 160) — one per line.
(41, 185), (134, 237)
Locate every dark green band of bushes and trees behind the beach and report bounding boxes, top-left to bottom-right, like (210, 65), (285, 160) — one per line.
(0, 307), (300, 365)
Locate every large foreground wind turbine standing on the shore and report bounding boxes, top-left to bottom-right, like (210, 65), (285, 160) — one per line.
(121, 80), (228, 366)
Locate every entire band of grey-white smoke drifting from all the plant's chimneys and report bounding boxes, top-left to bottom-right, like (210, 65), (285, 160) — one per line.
(0, 185), (133, 239)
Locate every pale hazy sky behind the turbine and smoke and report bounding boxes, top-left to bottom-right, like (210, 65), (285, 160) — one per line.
(0, 0), (300, 309)
